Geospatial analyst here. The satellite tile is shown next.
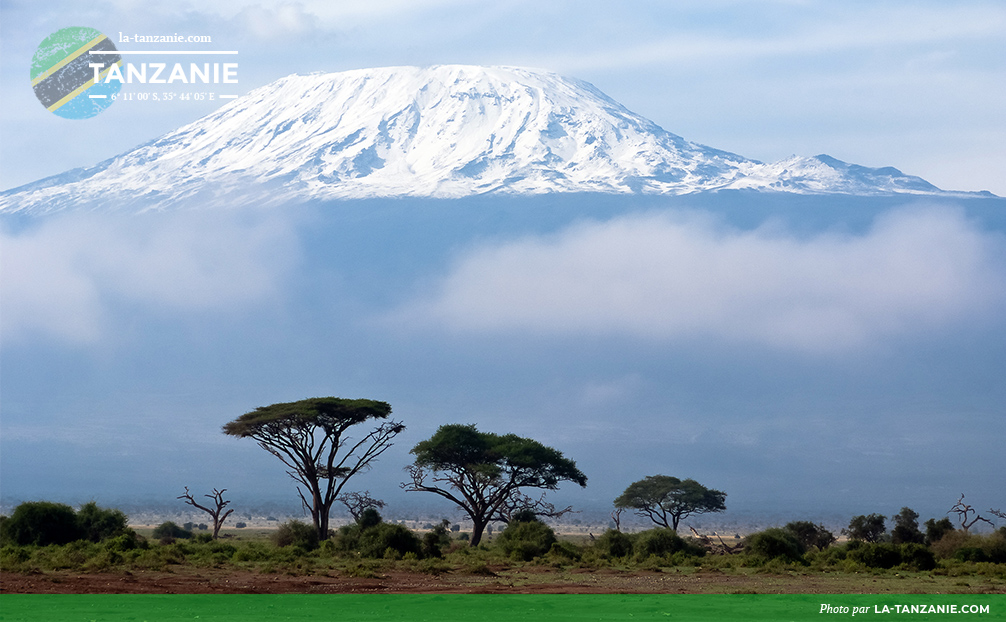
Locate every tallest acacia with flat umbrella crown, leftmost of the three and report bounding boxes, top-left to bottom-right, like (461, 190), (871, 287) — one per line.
(223, 398), (405, 539)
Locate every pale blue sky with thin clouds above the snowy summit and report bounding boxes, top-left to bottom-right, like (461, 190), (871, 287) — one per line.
(0, 0), (1006, 195)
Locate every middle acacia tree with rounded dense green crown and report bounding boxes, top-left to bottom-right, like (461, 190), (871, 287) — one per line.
(401, 424), (586, 547)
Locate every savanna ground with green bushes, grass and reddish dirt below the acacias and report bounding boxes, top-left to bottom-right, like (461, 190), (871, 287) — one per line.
(0, 505), (1006, 594)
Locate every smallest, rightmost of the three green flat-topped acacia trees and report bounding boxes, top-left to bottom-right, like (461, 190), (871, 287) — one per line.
(615, 475), (726, 531)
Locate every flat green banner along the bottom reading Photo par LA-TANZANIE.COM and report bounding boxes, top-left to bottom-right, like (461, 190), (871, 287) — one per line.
(0, 594), (1006, 622)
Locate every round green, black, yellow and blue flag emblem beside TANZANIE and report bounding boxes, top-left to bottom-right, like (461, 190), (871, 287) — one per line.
(31, 26), (123, 119)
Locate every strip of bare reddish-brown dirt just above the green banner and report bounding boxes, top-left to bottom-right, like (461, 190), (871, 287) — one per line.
(0, 569), (1006, 594)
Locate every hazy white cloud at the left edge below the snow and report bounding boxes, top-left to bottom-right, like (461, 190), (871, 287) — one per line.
(0, 211), (298, 342)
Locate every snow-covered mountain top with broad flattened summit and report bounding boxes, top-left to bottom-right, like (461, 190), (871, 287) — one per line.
(0, 65), (977, 211)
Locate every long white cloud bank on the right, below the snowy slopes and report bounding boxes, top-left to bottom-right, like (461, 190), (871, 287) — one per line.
(392, 203), (1006, 351)
